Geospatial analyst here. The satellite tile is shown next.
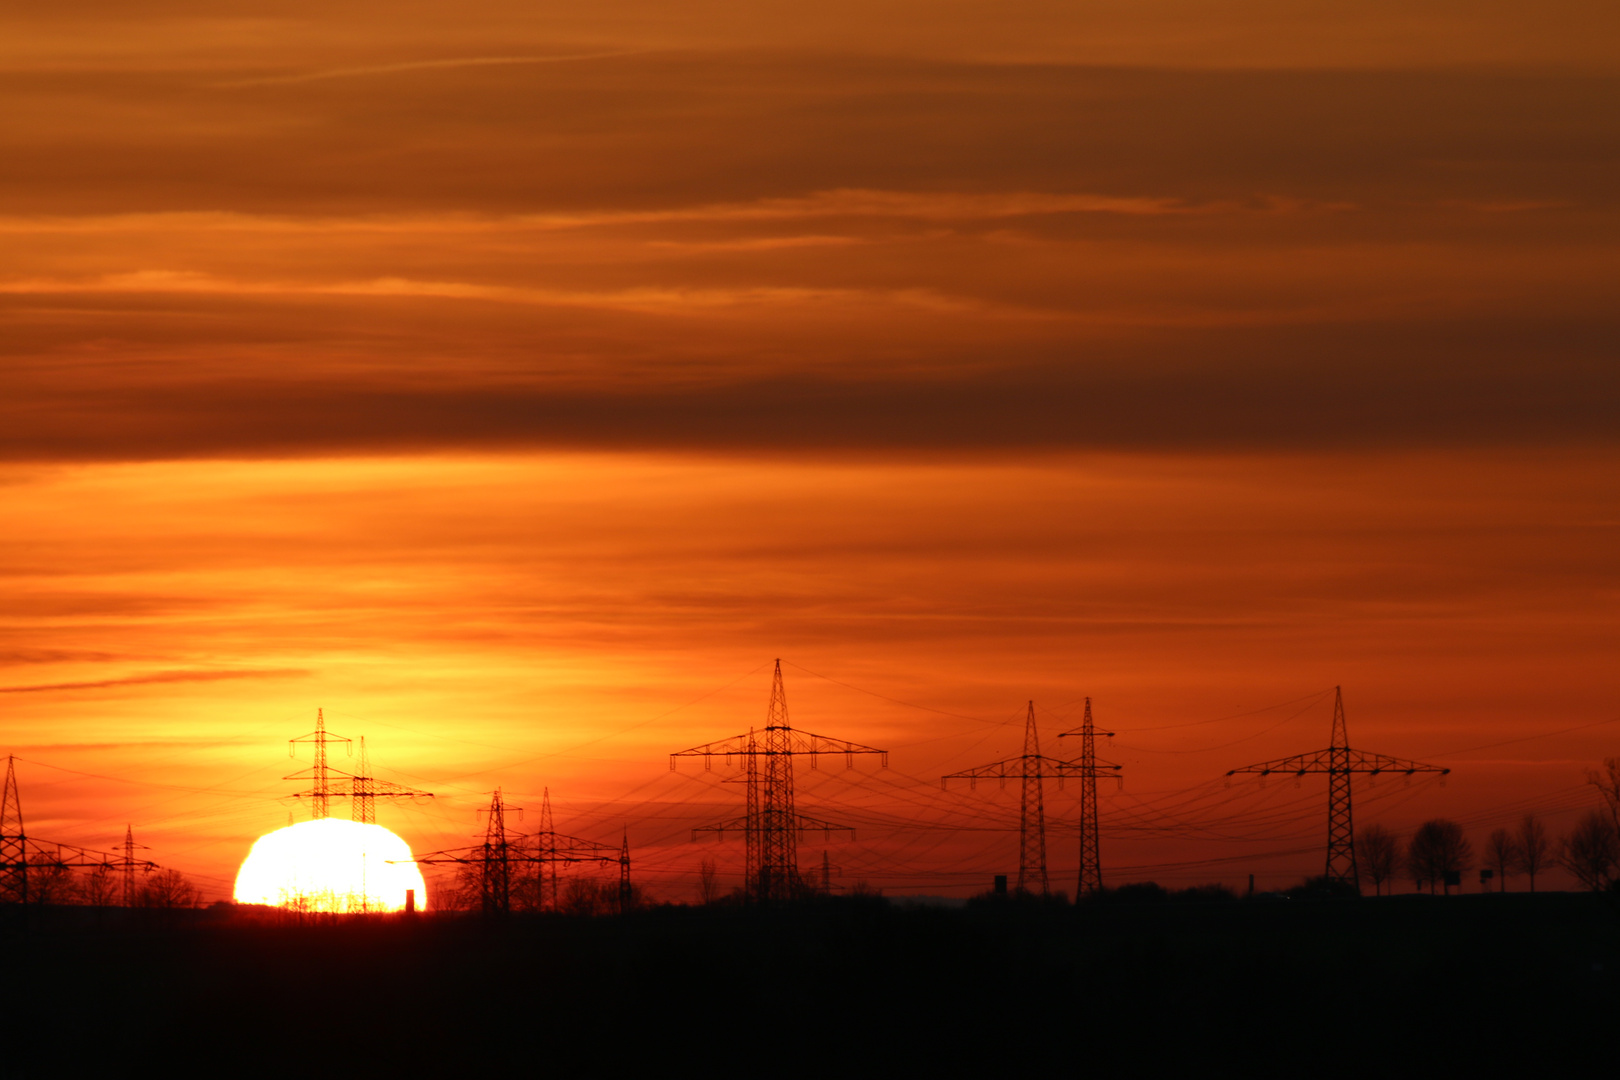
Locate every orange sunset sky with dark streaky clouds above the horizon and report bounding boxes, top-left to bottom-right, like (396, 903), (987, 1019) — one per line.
(0, 0), (1620, 900)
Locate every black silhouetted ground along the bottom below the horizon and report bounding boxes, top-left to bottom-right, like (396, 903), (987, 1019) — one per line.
(0, 894), (1620, 1077)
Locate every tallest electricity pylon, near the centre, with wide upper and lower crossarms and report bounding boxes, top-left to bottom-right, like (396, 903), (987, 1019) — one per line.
(669, 661), (889, 904)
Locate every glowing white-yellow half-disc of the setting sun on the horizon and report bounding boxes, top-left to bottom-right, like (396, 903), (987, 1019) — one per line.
(235, 818), (428, 912)
